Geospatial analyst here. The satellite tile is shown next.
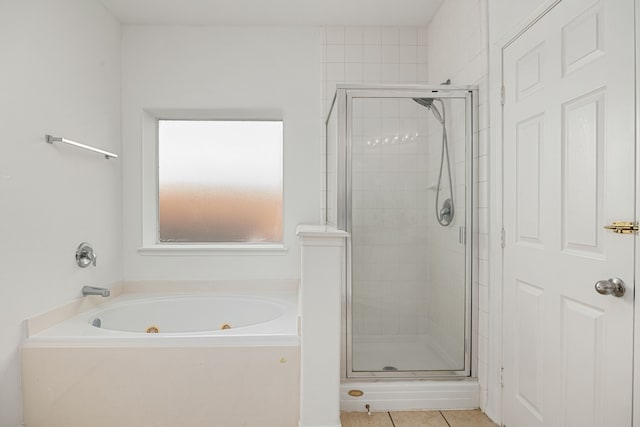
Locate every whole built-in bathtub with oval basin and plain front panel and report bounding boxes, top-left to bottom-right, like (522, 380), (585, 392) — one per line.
(22, 293), (300, 427)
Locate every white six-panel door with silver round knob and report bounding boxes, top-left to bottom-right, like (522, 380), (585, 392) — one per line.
(503, 0), (635, 427)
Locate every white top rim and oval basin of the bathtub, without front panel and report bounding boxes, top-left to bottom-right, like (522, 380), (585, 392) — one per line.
(26, 293), (300, 346)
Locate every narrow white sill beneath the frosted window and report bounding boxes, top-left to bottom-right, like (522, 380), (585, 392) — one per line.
(138, 243), (288, 256)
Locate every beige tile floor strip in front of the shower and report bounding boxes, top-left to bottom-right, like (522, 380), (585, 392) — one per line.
(340, 409), (497, 427)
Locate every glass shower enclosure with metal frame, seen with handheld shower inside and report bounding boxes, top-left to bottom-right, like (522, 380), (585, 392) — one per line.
(325, 85), (477, 379)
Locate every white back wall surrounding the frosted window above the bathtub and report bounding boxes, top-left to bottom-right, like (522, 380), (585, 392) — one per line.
(122, 26), (322, 280)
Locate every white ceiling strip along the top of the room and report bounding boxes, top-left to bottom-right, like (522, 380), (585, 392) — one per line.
(100, 0), (444, 26)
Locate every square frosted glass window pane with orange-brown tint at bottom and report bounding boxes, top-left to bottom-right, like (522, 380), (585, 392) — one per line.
(158, 120), (283, 243)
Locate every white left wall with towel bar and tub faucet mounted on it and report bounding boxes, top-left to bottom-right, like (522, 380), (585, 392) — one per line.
(0, 0), (122, 427)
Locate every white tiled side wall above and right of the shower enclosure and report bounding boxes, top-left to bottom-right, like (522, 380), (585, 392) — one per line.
(427, 0), (490, 409)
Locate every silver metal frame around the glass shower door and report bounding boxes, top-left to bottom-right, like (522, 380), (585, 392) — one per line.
(336, 85), (478, 380)
